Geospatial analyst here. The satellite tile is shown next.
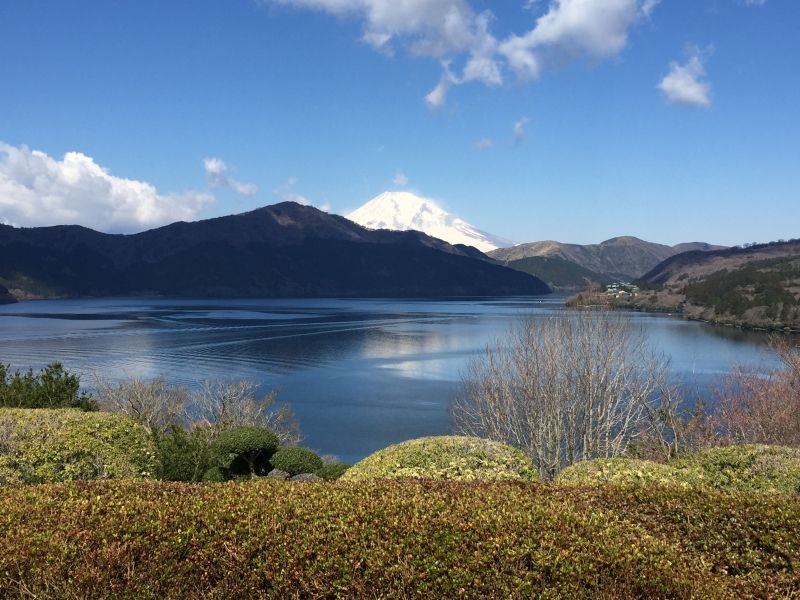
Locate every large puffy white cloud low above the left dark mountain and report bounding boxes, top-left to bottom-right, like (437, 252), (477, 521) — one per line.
(0, 142), (214, 232)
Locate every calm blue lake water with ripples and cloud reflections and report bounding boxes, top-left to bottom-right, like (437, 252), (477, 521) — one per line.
(0, 296), (774, 461)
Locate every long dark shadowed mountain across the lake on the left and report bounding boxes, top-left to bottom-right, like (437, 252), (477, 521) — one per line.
(0, 202), (549, 297)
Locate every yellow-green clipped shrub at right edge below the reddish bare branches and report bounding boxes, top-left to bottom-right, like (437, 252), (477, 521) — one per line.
(670, 445), (800, 493)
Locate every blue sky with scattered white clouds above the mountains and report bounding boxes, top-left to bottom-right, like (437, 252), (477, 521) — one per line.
(0, 0), (800, 245)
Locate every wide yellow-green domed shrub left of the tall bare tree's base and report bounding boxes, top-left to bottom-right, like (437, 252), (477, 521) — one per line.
(341, 436), (538, 481)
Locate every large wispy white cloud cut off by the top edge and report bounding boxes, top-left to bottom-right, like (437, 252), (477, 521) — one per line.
(268, 0), (660, 110)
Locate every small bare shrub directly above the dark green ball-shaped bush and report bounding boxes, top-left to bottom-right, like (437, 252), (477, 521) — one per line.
(191, 380), (302, 446)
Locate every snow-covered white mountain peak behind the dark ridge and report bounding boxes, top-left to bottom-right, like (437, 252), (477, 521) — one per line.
(347, 192), (512, 252)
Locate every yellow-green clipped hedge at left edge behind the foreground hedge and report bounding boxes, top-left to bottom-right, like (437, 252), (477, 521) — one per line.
(0, 408), (158, 485)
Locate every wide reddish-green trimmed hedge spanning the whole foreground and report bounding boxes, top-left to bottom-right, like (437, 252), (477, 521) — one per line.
(0, 480), (800, 599)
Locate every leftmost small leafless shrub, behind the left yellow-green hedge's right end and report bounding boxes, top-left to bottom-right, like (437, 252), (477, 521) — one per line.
(96, 376), (189, 434)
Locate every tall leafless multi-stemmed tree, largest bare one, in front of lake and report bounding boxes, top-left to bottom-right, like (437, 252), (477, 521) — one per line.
(451, 311), (676, 479)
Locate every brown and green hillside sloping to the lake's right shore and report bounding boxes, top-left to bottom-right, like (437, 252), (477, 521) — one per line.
(583, 240), (800, 330)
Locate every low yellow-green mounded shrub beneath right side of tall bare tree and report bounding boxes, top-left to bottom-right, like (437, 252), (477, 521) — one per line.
(556, 458), (701, 486)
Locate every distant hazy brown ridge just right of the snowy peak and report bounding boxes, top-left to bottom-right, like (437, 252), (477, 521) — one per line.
(489, 236), (722, 280)
